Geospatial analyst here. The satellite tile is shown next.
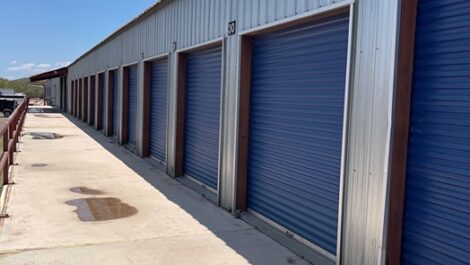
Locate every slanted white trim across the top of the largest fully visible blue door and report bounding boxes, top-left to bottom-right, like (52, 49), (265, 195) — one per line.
(238, 0), (355, 35)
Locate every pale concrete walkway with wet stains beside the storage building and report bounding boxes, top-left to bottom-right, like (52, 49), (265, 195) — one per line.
(0, 108), (307, 265)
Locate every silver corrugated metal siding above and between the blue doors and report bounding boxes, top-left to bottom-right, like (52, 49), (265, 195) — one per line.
(62, 0), (400, 264)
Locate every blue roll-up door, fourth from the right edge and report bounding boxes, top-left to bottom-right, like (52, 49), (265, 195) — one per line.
(150, 60), (168, 162)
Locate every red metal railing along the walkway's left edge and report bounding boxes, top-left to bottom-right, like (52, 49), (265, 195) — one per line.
(0, 98), (29, 187)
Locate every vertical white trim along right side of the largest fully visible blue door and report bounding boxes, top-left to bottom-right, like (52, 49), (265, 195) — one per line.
(336, 3), (354, 265)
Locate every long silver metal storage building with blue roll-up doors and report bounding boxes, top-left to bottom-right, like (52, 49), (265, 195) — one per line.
(35, 0), (470, 264)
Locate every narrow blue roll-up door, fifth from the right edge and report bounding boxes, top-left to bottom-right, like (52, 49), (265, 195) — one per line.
(127, 65), (137, 147)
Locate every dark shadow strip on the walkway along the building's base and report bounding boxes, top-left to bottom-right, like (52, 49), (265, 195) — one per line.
(62, 110), (308, 265)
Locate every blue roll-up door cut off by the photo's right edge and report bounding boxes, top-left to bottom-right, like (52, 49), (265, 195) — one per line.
(402, 0), (470, 265)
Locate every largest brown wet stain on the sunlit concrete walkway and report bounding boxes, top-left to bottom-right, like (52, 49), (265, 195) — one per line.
(65, 197), (138, 222)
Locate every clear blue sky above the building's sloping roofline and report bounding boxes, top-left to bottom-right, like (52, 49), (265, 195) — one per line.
(0, 0), (156, 79)
